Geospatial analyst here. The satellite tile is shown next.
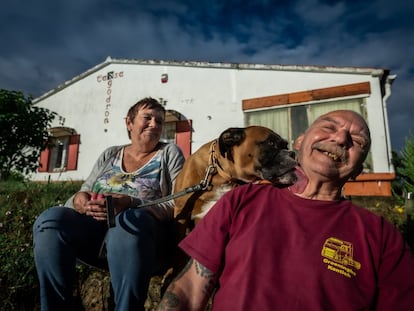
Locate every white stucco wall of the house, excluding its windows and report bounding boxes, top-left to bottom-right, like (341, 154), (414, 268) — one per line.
(33, 61), (390, 180)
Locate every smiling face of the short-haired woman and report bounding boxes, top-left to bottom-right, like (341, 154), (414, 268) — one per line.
(126, 107), (165, 144)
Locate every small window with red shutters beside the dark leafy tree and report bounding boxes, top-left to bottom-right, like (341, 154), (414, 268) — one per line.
(38, 127), (80, 173)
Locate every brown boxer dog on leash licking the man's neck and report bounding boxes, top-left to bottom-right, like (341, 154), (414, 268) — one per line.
(174, 126), (296, 235)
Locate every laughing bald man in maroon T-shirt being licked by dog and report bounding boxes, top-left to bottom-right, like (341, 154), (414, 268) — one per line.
(159, 110), (414, 311)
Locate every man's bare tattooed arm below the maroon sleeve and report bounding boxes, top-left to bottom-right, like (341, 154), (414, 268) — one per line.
(158, 258), (217, 311)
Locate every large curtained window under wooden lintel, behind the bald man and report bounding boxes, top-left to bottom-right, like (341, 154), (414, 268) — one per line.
(243, 83), (372, 172)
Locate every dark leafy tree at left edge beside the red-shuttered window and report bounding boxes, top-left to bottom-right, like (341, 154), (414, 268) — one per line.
(0, 89), (57, 180)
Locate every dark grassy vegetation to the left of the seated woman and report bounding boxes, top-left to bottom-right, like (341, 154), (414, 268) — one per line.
(0, 181), (80, 311)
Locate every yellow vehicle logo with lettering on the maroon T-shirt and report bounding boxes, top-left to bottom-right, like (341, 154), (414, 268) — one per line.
(321, 237), (361, 278)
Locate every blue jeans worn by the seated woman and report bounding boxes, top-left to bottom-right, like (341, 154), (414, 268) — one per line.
(33, 207), (172, 311)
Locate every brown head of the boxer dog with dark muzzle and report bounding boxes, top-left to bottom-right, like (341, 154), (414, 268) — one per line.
(218, 126), (296, 185)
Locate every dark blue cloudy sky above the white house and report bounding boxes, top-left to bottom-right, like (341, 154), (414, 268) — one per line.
(0, 0), (414, 150)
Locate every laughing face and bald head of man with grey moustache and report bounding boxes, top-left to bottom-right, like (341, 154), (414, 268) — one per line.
(295, 110), (370, 183)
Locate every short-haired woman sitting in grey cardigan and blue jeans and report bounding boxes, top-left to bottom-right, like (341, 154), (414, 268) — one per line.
(33, 98), (184, 311)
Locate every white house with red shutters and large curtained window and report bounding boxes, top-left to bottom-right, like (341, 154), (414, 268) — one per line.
(32, 57), (395, 195)
